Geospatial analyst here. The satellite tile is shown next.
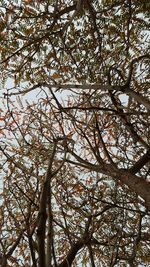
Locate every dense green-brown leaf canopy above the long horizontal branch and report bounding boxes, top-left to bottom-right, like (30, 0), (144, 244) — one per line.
(0, 1), (149, 85)
